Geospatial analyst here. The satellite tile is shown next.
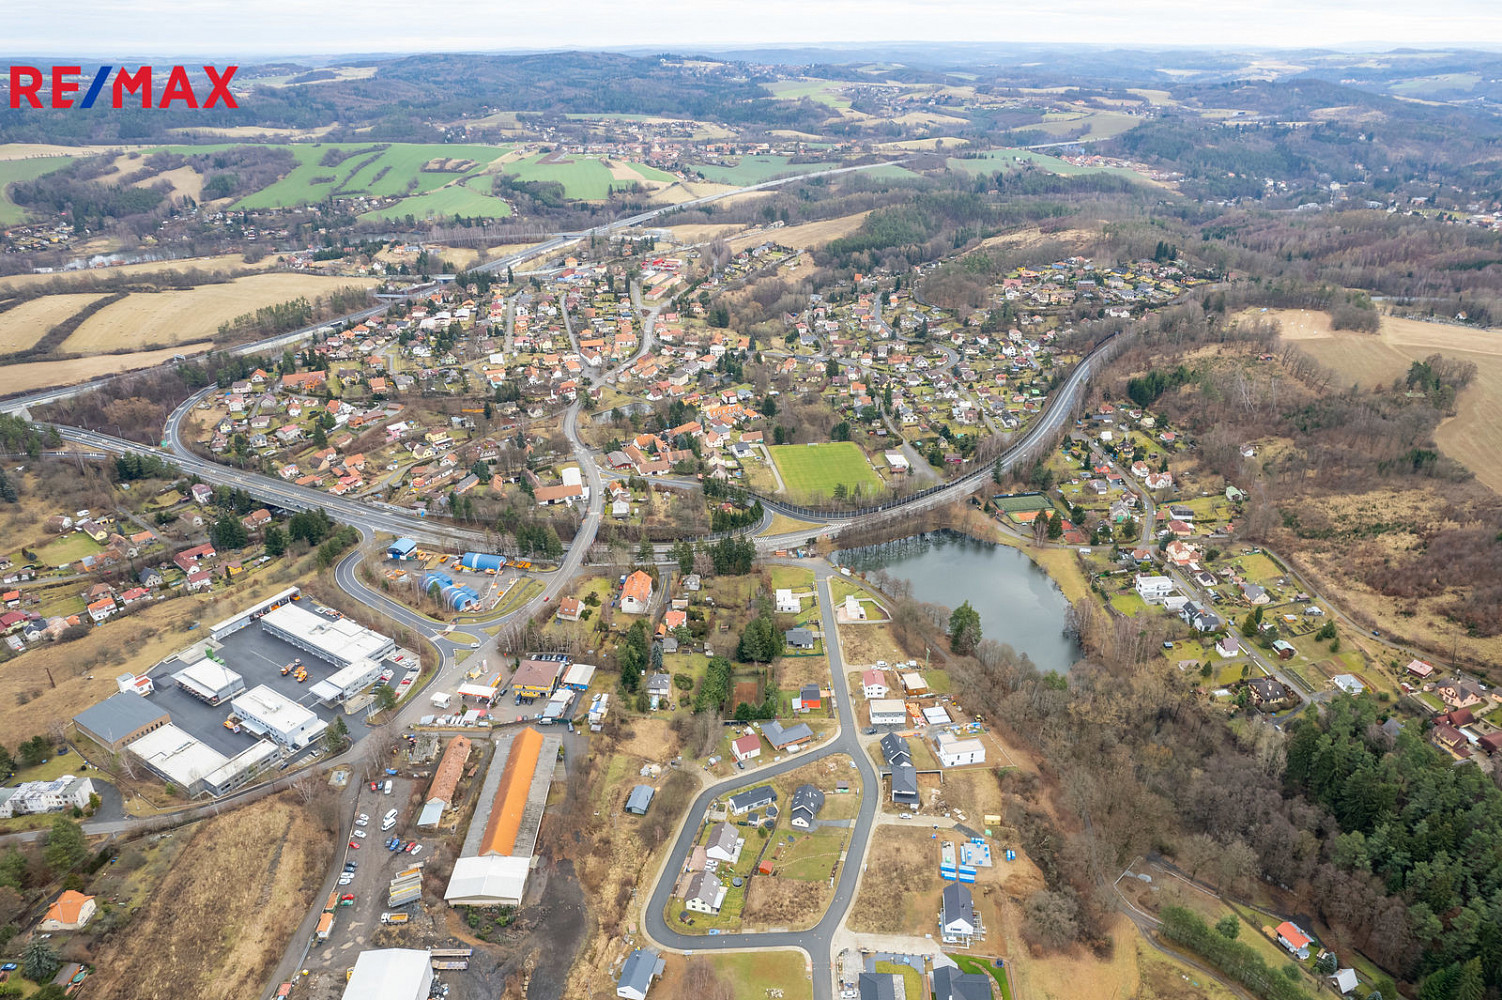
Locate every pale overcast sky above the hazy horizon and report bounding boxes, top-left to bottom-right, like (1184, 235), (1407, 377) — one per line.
(0, 0), (1502, 59)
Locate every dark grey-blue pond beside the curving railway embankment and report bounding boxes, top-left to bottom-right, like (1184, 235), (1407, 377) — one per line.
(831, 532), (1080, 673)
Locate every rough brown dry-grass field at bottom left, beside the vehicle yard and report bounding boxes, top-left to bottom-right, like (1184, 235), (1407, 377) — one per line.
(89, 796), (333, 1000)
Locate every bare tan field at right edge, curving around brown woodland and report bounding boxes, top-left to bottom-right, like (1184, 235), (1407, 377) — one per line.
(1268, 309), (1502, 492)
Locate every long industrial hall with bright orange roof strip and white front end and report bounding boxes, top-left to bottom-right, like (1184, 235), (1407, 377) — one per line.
(443, 727), (560, 905)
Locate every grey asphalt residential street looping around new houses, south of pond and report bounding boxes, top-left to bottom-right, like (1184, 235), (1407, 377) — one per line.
(643, 563), (882, 1000)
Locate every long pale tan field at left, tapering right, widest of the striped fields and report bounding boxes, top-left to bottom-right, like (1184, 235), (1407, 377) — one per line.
(62, 273), (380, 353)
